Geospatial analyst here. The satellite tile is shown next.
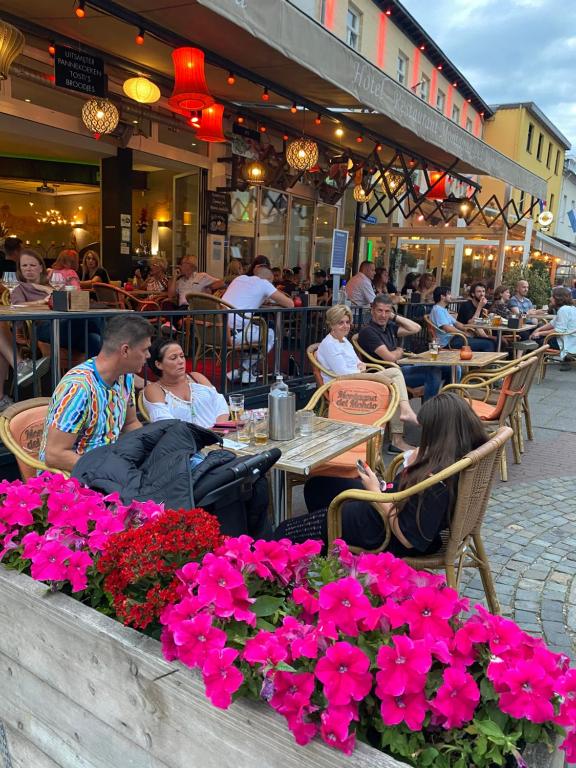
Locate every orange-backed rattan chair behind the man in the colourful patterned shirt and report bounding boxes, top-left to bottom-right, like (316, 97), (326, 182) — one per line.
(0, 397), (67, 480)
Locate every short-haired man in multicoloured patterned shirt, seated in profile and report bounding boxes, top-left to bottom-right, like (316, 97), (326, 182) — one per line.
(39, 314), (152, 472)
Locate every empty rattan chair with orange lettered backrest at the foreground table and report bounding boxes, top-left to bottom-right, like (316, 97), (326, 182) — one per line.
(286, 373), (400, 515)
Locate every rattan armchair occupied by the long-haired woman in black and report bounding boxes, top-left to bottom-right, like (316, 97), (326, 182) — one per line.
(328, 427), (512, 613)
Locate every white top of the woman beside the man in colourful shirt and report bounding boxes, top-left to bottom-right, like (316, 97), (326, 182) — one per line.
(143, 378), (228, 429)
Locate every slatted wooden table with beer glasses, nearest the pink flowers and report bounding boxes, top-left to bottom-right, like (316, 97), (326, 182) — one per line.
(224, 395), (381, 524)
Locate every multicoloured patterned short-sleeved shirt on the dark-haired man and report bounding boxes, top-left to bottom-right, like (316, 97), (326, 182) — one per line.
(39, 358), (134, 461)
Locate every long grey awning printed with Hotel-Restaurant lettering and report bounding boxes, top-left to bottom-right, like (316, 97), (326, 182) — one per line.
(194, 0), (546, 199)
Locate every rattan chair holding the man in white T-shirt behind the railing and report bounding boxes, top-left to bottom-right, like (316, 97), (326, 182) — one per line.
(184, 293), (270, 390)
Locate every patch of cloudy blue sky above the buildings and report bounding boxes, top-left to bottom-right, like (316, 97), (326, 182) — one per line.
(401, 0), (576, 155)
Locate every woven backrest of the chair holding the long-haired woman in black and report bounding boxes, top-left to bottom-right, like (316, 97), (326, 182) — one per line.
(446, 427), (512, 562)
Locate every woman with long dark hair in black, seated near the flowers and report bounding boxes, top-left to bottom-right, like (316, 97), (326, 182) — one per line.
(274, 392), (488, 557)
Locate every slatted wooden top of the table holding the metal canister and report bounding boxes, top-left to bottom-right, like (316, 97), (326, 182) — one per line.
(224, 416), (381, 475)
